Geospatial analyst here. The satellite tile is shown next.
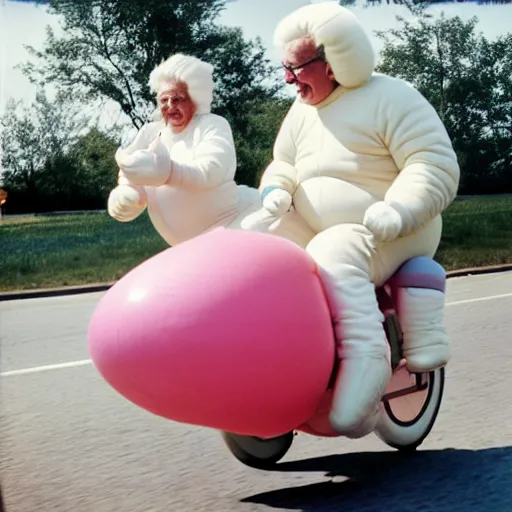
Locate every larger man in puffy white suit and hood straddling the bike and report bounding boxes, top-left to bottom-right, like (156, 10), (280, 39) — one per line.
(243, 2), (459, 437)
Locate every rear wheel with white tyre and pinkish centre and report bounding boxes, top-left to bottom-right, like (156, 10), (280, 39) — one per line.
(375, 368), (445, 451)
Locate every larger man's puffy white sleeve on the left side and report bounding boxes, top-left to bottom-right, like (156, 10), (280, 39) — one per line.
(259, 103), (297, 195)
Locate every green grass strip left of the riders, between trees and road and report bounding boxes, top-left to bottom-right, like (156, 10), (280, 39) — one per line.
(0, 213), (167, 291)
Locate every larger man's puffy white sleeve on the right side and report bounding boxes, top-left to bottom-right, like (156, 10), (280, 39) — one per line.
(377, 79), (460, 236)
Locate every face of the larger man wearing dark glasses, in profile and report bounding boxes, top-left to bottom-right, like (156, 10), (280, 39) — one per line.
(283, 38), (335, 105)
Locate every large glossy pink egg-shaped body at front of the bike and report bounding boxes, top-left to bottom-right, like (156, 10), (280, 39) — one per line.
(88, 228), (335, 437)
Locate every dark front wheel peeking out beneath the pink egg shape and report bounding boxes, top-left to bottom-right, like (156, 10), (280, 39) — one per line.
(222, 432), (294, 469)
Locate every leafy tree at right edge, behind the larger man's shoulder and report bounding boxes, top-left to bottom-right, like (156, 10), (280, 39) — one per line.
(377, 14), (512, 193)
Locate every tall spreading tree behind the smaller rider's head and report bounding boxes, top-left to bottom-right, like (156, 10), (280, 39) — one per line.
(23, 0), (279, 129)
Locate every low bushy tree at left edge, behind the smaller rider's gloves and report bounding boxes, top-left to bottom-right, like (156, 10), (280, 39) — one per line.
(0, 91), (121, 213)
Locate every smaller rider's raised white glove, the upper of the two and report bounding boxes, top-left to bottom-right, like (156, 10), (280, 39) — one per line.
(116, 136), (172, 187)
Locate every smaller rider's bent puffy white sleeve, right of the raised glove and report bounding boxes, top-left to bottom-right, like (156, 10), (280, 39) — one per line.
(167, 115), (237, 189)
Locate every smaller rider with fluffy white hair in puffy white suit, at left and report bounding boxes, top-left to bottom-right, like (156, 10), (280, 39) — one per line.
(108, 54), (278, 246)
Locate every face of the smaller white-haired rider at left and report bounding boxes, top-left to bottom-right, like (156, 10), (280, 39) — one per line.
(158, 82), (196, 133)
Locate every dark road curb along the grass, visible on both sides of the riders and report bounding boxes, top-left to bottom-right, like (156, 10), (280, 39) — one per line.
(0, 263), (512, 302)
